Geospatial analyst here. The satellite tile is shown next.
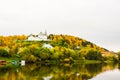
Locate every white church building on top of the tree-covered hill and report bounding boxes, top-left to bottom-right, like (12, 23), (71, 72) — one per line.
(27, 31), (48, 41)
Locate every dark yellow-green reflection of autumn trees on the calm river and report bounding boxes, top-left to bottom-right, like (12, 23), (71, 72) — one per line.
(0, 63), (119, 80)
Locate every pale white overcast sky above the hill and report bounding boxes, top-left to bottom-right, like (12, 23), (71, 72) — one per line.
(0, 0), (120, 51)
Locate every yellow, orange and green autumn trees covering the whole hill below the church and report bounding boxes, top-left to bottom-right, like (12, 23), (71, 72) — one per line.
(0, 34), (119, 62)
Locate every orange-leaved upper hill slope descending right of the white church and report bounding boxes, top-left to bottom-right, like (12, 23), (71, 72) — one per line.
(48, 34), (108, 52)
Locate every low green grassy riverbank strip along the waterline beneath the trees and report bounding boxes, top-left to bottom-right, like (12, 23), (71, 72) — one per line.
(0, 57), (114, 64)
